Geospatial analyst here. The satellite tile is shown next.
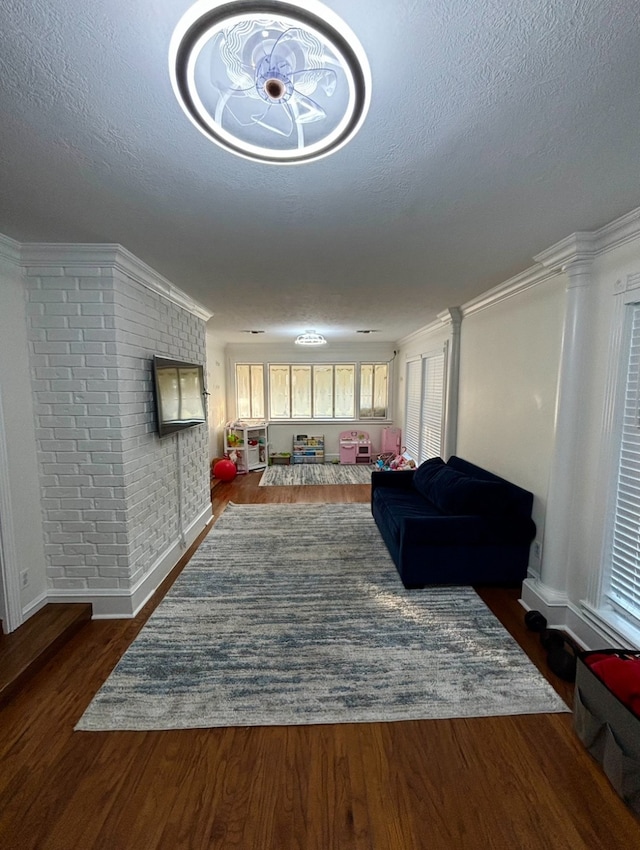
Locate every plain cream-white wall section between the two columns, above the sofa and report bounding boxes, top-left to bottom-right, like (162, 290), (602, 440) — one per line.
(457, 275), (565, 539)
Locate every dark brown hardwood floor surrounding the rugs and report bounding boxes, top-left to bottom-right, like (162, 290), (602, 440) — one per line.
(0, 473), (640, 850)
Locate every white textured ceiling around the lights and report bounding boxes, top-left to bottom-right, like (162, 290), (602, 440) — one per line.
(0, 0), (640, 342)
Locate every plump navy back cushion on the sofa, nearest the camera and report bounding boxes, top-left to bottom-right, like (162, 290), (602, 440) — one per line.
(420, 464), (511, 516)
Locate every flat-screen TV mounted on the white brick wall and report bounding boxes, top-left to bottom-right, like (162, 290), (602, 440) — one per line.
(153, 356), (207, 437)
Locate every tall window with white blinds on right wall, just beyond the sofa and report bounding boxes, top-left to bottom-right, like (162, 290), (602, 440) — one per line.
(404, 351), (445, 463)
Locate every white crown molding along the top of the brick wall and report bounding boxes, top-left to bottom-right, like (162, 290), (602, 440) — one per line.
(21, 242), (213, 322)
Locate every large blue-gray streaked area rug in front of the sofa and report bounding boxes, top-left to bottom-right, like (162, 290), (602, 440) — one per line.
(76, 503), (569, 730)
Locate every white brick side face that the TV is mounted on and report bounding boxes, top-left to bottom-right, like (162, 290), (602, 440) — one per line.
(115, 273), (209, 584)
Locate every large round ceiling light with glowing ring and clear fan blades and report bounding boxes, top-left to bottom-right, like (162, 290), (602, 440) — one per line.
(169, 0), (371, 164)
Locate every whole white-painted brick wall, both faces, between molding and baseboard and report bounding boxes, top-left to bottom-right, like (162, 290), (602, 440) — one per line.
(26, 265), (208, 591)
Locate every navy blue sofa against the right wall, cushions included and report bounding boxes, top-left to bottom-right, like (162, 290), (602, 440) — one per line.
(371, 455), (536, 588)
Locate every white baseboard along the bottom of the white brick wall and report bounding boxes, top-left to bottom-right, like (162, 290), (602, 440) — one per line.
(45, 504), (213, 620)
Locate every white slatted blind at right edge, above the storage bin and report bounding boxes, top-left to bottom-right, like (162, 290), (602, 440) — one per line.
(606, 304), (640, 626)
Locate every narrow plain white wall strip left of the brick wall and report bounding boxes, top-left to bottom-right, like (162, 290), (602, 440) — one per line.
(0, 237), (46, 617)
